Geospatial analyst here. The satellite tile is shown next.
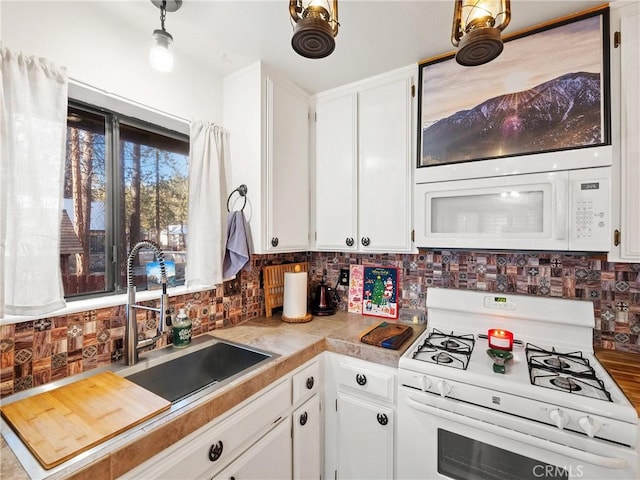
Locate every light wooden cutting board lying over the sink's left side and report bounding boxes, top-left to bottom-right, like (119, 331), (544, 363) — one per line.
(0, 372), (171, 469)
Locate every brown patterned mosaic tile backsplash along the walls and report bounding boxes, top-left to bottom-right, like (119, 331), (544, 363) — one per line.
(0, 249), (640, 396)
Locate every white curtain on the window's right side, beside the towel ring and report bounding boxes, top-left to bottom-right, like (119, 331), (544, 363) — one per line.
(185, 121), (229, 286)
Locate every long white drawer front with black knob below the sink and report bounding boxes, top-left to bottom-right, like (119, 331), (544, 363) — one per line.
(120, 379), (291, 479)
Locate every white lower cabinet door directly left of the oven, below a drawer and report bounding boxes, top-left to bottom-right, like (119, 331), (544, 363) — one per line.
(336, 392), (394, 480)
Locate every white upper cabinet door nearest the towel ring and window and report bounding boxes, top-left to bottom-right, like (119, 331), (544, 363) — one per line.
(265, 78), (309, 252)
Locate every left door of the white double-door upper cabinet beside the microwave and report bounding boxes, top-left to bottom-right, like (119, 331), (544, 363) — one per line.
(314, 93), (358, 251)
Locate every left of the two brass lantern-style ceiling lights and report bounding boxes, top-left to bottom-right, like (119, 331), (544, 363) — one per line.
(289, 0), (340, 58)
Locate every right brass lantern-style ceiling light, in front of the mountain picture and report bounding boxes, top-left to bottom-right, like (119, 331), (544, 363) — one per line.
(451, 0), (511, 67)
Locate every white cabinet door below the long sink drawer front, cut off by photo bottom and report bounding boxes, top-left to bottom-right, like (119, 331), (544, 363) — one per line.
(210, 417), (291, 480)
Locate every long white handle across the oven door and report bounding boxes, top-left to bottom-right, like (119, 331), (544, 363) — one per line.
(407, 397), (627, 470)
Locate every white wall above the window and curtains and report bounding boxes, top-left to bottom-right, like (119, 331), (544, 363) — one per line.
(0, 0), (222, 124)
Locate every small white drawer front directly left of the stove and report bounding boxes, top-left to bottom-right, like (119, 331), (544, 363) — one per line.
(334, 358), (396, 402)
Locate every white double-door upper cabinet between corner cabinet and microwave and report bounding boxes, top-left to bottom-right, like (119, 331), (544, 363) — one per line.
(314, 66), (416, 252)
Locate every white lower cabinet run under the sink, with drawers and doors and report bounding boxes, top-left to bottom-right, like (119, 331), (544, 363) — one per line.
(121, 358), (323, 480)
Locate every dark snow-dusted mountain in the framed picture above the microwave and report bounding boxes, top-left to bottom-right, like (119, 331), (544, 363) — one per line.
(422, 72), (602, 165)
